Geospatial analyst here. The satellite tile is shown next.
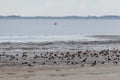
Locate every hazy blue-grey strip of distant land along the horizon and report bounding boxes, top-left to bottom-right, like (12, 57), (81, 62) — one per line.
(0, 15), (120, 19)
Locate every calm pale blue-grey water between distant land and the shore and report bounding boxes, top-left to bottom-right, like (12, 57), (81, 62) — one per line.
(0, 19), (120, 40)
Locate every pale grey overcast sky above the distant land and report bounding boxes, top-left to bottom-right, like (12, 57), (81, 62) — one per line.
(0, 0), (120, 16)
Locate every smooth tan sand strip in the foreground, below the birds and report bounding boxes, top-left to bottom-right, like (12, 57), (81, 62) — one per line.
(0, 65), (120, 80)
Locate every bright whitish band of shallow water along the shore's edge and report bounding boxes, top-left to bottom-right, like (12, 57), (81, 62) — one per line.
(0, 35), (108, 42)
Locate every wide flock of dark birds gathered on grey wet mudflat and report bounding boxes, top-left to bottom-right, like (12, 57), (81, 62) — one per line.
(0, 49), (120, 67)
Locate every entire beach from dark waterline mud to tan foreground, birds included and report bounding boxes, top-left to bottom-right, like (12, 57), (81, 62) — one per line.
(0, 36), (120, 80)
